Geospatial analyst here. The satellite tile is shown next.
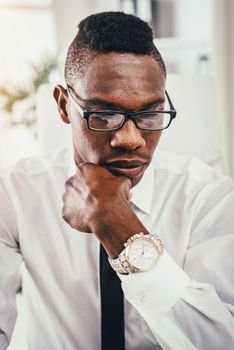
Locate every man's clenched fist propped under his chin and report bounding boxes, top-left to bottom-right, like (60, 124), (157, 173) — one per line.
(63, 163), (131, 232)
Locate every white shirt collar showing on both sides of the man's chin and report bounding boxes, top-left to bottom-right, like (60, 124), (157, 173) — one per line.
(68, 155), (153, 214)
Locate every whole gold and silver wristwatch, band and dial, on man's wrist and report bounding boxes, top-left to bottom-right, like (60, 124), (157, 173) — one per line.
(108, 232), (163, 275)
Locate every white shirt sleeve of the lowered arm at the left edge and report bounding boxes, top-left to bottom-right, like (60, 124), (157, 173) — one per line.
(0, 181), (22, 350)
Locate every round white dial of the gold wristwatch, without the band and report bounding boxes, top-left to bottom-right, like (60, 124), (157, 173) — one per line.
(126, 237), (159, 270)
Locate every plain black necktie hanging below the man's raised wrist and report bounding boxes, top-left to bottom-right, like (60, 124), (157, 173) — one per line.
(100, 245), (125, 350)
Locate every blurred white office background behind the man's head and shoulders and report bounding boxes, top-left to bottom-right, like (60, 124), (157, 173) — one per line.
(0, 0), (234, 177)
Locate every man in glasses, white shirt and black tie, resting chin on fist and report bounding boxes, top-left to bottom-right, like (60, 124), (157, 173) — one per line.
(0, 12), (234, 350)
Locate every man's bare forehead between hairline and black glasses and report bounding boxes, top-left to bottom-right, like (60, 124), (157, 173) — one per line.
(74, 53), (165, 109)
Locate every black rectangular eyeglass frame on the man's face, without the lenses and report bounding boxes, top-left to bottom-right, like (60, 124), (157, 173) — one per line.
(67, 85), (177, 132)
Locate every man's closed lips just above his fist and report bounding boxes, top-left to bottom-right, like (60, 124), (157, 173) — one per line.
(103, 159), (145, 178)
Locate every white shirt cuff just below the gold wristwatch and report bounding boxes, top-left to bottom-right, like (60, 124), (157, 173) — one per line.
(118, 250), (191, 321)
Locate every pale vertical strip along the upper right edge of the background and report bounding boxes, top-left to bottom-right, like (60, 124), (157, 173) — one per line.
(214, 0), (234, 177)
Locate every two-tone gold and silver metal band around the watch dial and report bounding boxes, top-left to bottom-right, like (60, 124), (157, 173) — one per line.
(108, 232), (163, 275)
